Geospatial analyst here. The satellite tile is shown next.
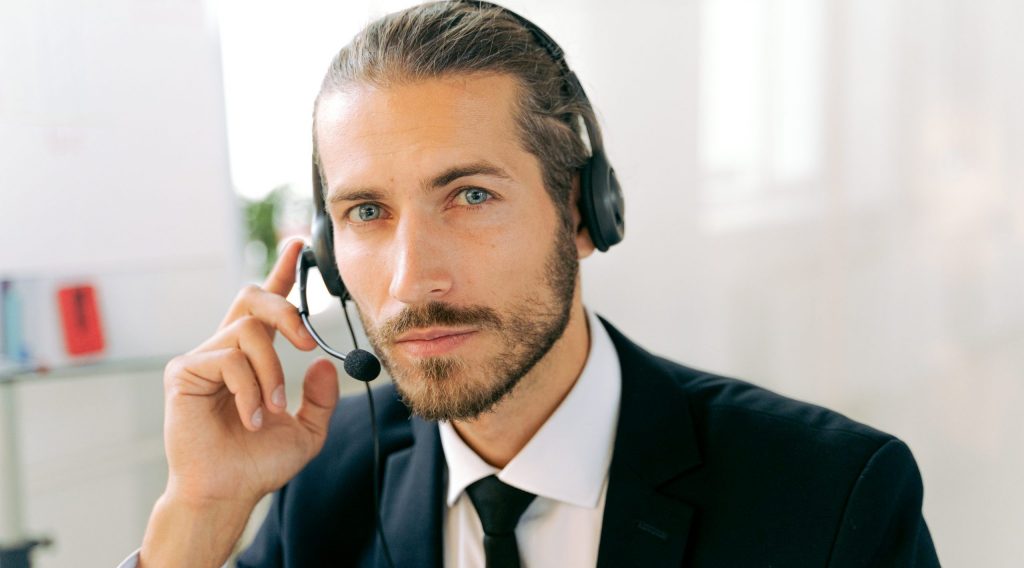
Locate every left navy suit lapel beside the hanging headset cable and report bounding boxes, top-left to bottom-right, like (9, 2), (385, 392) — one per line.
(374, 417), (444, 568)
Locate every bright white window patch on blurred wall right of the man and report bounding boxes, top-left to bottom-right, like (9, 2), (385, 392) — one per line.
(699, 0), (824, 217)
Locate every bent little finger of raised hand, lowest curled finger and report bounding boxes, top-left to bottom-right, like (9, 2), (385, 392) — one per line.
(165, 348), (262, 432)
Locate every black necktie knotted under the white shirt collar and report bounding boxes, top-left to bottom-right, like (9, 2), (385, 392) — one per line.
(466, 475), (537, 568)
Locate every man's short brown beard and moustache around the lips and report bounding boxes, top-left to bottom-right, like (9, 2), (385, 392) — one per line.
(359, 223), (580, 421)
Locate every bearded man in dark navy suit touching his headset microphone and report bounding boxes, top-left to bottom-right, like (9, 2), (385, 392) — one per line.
(128, 2), (938, 567)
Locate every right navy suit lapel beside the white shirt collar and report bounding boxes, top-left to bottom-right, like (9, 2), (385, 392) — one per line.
(597, 320), (700, 568)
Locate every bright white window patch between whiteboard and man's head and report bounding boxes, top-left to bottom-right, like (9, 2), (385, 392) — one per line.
(215, 0), (370, 199)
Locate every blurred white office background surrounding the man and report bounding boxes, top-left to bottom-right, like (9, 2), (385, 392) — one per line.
(0, 0), (1024, 567)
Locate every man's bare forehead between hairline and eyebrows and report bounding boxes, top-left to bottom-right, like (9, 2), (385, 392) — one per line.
(315, 74), (537, 193)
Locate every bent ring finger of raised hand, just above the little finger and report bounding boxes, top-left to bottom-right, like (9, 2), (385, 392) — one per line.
(197, 316), (287, 413)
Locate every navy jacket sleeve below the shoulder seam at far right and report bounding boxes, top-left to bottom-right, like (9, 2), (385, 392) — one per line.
(828, 439), (939, 568)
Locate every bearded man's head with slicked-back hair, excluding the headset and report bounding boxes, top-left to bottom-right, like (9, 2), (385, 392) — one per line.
(314, 2), (593, 420)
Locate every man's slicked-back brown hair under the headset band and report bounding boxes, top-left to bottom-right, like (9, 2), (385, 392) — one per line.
(313, 1), (596, 230)
